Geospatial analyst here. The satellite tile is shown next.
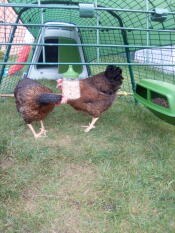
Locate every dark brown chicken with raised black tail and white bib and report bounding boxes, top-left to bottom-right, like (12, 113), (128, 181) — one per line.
(57, 65), (123, 132)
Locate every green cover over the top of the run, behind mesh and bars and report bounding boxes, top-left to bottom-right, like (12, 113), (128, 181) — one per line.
(8, 0), (175, 60)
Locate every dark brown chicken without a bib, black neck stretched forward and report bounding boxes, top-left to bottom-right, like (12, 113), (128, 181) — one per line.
(14, 78), (62, 138)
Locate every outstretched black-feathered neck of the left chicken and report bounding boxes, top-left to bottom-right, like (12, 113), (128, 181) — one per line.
(37, 93), (62, 105)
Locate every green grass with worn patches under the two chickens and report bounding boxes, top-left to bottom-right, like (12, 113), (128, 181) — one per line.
(0, 97), (175, 233)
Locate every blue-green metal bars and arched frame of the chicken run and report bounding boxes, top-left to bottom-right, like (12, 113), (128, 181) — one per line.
(0, 0), (175, 93)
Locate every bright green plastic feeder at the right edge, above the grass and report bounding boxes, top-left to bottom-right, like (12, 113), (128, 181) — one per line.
(134, 79), (175, 125)
